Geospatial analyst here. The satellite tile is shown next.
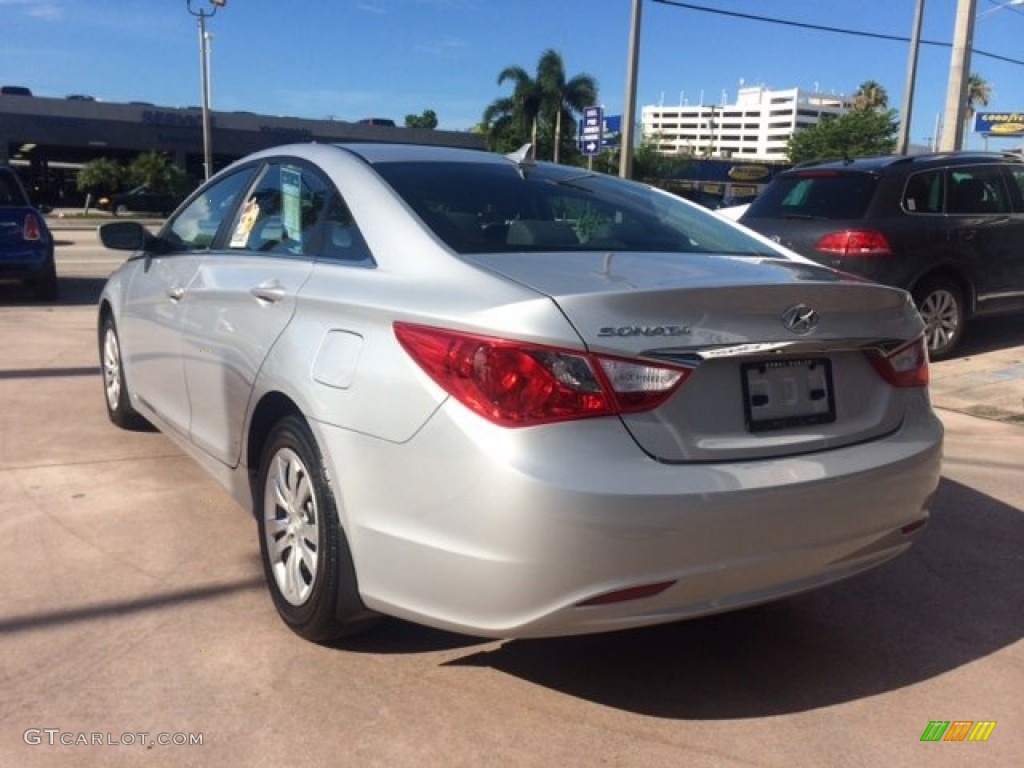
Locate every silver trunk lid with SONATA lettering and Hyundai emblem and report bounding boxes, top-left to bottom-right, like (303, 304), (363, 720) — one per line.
(475, 253), (922, 462)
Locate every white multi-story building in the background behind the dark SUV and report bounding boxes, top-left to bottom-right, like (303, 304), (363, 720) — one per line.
(641, 86), (852, 163)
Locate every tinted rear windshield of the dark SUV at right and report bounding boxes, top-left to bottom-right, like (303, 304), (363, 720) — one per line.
(743, 171), (879, 220)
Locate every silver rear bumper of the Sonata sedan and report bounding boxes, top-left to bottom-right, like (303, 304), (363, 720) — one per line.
(314, 396), (942, 637)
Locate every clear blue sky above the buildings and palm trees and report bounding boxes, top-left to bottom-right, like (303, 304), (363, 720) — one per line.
(0, 0), (1024, 148)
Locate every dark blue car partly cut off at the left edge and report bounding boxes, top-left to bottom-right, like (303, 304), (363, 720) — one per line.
(0, 167), (57, 301)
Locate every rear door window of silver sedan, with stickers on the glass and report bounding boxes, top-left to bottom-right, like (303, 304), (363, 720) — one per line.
(228, 163), (330, 256)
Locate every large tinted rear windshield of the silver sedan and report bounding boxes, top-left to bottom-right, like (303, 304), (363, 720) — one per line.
(374, 161), (778, 257)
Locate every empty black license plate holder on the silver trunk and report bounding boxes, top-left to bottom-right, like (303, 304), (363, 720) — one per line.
(741, 357), (836, 432)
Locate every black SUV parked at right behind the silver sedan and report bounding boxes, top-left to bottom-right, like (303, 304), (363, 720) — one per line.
(739, 153), (1024, 359)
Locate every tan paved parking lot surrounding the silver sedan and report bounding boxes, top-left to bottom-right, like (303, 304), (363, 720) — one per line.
(0, 228), (1024, 768)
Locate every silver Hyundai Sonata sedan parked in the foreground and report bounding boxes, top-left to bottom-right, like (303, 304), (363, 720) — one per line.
(98, 144), (942, 642)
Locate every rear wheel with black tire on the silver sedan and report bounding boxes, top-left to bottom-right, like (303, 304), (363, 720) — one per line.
(253, 415), (376, 643)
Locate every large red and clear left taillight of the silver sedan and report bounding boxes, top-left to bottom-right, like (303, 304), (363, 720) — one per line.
(394, 323), (690, 427)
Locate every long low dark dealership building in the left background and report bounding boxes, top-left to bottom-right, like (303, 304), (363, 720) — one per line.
(0, 93), (484, 205)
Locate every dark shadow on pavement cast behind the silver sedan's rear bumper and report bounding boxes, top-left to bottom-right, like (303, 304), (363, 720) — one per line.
(428, 479), (1024, 720)
